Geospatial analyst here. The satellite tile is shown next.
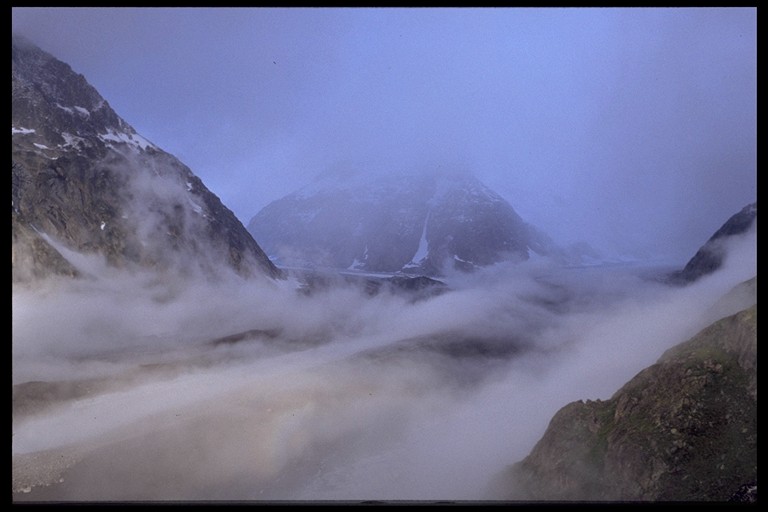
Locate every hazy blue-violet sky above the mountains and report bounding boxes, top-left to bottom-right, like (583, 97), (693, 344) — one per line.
(13, 8), (757, 260)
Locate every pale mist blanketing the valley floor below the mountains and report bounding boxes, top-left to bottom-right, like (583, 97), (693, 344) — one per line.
(12, 223), (756, 501)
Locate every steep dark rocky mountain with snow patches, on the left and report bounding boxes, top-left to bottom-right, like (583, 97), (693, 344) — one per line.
(11, 35), (280, 282)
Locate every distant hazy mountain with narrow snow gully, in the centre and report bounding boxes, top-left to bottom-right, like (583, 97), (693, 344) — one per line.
(248, 171), (553, 276)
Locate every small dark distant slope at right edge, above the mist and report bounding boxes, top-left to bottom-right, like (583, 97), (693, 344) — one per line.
(669, 203), (757, 284)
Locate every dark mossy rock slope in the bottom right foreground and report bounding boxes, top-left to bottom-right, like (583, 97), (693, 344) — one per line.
(503, 305), (757, 501)
